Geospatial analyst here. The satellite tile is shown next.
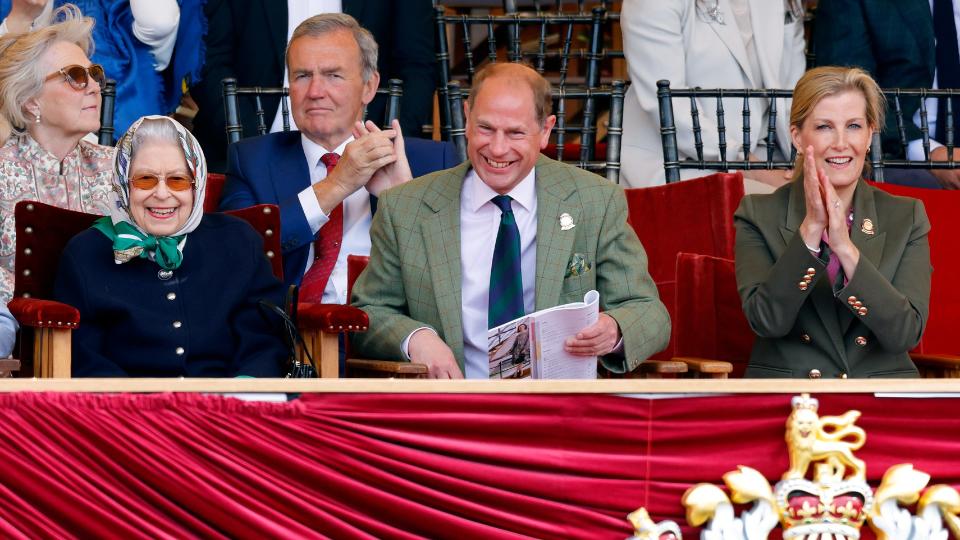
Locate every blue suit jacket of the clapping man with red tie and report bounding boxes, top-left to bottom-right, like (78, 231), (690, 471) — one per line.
(220, 131), (460, 285)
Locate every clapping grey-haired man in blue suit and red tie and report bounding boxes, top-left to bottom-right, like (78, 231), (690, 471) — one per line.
(220, 13), (458, 304)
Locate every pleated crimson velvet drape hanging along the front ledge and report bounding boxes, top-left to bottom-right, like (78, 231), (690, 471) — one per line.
(0, 394), (960, 538)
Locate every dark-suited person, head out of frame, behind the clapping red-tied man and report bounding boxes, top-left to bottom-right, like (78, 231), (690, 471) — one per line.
(190, 0), (437, 172)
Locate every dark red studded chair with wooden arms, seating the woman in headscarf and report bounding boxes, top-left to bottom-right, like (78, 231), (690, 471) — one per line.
(9, 201), (367, 378)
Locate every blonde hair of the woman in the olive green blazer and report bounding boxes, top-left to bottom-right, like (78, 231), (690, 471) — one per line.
(790, 66), (887, 180)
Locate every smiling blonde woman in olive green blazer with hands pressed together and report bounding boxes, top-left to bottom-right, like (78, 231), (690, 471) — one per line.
(734, 67), (932, 378)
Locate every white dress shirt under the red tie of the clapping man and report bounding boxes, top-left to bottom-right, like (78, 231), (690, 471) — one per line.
(298, 135), (373, 304)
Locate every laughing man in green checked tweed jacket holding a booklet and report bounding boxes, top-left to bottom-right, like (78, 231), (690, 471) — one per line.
(352, 63), (670, 378)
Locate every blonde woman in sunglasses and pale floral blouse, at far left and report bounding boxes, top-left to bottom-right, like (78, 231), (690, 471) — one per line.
(0, 7), (113, 303)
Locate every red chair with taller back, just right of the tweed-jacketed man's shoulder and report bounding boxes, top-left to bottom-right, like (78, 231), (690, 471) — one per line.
(625, 173), (743, 372)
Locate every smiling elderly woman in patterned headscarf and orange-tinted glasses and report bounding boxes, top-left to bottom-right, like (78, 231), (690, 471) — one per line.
(54, 116), (286, 377)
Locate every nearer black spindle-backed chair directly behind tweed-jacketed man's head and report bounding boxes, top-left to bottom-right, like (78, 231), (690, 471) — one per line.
(447, 81), (626, 184)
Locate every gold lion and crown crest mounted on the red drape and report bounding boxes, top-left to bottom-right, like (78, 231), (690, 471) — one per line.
(630, 394), (960, 540)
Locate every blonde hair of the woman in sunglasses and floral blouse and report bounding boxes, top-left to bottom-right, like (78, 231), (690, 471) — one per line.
(0, 4), (93, 144)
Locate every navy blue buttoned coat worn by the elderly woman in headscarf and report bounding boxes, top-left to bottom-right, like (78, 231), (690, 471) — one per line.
(54, 214), (287, 377)
